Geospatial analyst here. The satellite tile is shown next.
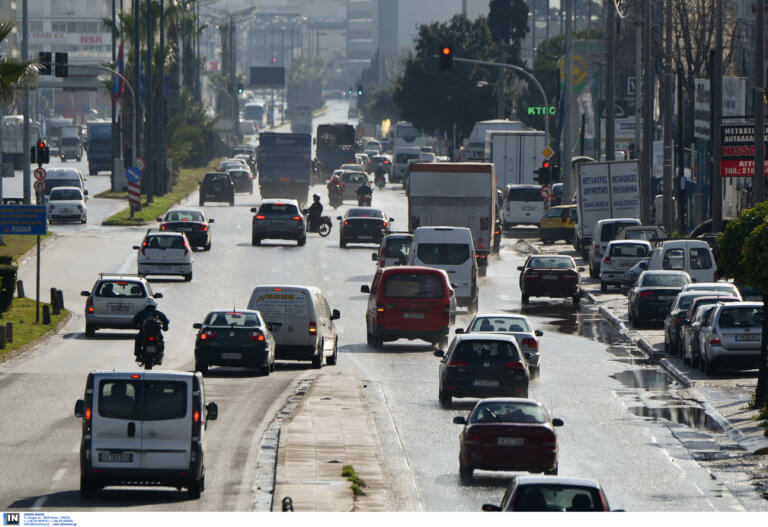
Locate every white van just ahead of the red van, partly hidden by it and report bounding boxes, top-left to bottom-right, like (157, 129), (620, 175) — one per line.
(408, 227), (478, 312)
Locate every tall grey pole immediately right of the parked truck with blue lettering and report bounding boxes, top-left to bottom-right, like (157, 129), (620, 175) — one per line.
(640, 0), (653, 225)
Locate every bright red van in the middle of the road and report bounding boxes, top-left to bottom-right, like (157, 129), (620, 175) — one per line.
(360, 266), (455, 349)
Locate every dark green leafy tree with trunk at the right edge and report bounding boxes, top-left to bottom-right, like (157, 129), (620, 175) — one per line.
(717, 202), (768, 408)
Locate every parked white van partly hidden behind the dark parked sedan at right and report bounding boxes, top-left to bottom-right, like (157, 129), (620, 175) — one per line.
(648, 240), (717, 282)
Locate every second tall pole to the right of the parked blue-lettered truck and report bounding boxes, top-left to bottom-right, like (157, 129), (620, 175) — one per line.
(664, 0), (679, 233)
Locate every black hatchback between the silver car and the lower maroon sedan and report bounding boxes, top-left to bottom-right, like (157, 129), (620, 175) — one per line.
(435, 333), (530, 408)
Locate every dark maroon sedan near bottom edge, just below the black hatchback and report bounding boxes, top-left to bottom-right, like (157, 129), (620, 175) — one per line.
(453, 397), (563, 484)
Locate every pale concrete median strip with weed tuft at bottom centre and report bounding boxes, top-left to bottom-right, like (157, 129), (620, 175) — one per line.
(273, 372), (392, 512)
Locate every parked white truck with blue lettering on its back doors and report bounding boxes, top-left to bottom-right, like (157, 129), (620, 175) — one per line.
(573, 160), (640, 257)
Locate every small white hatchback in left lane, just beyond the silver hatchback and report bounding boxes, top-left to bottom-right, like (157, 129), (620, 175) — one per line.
(133, 232), (193, 282)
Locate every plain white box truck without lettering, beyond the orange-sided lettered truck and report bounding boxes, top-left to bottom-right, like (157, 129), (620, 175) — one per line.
(485, 130), (547, 190)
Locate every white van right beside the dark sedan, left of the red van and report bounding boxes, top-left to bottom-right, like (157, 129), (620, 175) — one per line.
(248, 285), (341, 368)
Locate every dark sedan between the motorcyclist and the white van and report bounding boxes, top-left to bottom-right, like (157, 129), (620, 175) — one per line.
(192, 310), (275, 375)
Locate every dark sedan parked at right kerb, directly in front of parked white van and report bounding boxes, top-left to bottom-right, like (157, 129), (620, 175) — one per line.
(627, 271), (691, 327)
